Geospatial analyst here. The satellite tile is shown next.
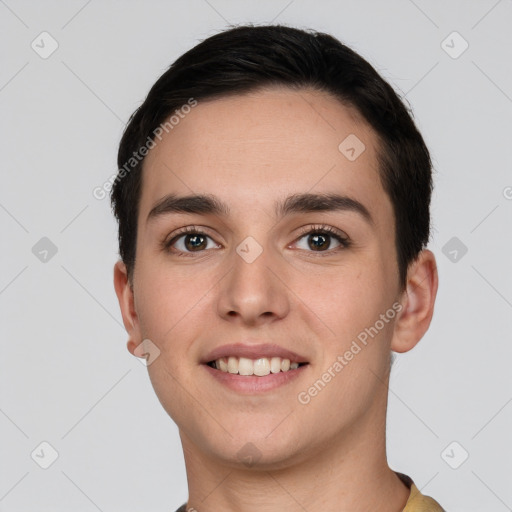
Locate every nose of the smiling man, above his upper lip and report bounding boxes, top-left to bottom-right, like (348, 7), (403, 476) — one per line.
(217, 241), (291, 326)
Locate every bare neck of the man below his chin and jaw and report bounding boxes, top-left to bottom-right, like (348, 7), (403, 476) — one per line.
(180, 380), (410, 512)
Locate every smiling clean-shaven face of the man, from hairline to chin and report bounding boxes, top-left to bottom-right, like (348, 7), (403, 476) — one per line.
(118, 89), (412, 467)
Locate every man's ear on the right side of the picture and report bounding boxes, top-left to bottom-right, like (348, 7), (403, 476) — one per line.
(391, 249), (438, 352)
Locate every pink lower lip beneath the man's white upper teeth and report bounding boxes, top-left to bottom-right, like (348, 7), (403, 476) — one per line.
(203, 364), (309, 395)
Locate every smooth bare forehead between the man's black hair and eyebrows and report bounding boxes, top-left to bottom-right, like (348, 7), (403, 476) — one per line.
(139, 88), (390, 224)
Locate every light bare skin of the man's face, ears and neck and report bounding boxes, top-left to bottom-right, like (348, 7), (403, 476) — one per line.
(114, 88), (438, 512)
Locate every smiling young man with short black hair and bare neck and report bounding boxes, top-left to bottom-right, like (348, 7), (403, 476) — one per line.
(111, 26), (443, 512)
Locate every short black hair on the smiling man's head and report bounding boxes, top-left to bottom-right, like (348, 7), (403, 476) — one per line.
(111, 24), (432, 289)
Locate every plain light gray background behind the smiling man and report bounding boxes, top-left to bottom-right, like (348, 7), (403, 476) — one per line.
(0, 0), (512, 512)
